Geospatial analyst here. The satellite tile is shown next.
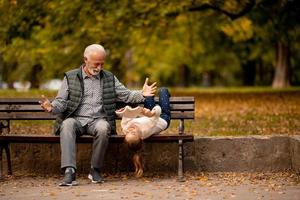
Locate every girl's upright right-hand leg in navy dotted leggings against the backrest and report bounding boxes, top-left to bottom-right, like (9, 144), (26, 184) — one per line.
(159, 87), (171, 126)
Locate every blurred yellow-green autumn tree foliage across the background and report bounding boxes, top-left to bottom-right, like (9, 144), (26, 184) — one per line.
(0, 0), (300, 87)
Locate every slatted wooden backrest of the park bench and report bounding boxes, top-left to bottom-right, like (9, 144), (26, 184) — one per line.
(0, 97), (195, 133)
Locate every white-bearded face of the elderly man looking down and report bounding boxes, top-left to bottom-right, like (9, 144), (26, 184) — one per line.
(84, 52), (105, 76)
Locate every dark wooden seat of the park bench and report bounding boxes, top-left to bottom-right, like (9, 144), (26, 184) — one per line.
(0, 134), (194, 143)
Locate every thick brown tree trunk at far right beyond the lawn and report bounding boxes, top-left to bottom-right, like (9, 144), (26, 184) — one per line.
(272, 42), (290, 88)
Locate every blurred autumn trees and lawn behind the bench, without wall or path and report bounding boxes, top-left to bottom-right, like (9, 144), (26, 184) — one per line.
(0, 0), (300, 136)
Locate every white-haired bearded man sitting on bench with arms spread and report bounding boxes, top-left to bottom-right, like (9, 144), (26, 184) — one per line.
(40, 44), (156, 186)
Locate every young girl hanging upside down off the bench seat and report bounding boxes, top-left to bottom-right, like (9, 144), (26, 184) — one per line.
(116, 88), (171, 177)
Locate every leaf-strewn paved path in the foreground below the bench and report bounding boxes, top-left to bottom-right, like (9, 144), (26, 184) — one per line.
(0, 173), (300, 200)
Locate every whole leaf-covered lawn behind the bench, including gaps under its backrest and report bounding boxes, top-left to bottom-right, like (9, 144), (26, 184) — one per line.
(0, 88), (300, 136)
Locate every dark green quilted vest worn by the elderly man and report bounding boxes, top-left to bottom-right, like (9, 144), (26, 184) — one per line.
(54, 67), (116, 135)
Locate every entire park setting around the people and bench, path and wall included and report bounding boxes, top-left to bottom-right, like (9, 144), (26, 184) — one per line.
(0, 0), (300, 199)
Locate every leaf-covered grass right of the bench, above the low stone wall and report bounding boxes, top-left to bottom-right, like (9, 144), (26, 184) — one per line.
(173, 91), (300, 136)
